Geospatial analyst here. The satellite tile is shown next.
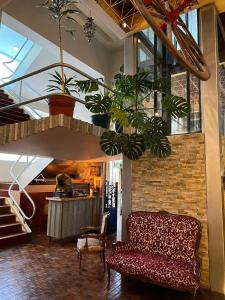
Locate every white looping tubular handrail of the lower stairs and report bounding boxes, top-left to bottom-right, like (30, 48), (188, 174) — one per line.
(8, 155), (36, 220)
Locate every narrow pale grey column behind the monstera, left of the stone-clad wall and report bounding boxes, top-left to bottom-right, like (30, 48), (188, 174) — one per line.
(122, 36), (137, 240)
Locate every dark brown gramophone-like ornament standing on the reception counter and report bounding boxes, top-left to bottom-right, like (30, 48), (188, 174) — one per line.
(55, 173), (73, 197)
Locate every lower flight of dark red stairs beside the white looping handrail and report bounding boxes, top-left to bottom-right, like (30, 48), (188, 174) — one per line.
(0, 197), (31, 249)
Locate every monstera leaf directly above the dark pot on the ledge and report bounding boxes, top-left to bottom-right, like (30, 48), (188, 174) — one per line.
(85, 94), (112, 114)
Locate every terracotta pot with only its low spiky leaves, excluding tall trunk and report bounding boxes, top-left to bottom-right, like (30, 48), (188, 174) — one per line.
(46, 71), (76, 117)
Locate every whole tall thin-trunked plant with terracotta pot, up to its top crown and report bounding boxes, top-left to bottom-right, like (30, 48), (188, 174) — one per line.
(40, 0), (79, 116)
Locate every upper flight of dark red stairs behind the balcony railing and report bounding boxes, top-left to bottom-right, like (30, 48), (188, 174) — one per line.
(0, 89), (30, 126)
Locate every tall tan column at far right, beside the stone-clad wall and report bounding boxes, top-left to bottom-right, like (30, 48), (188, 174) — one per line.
(200, 4), (225, 293)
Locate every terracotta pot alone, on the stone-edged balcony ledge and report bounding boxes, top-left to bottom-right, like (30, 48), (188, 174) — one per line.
(48, 94), (75, 117)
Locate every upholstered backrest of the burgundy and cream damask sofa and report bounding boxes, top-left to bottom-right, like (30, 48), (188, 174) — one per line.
(127, 212), (201, 262)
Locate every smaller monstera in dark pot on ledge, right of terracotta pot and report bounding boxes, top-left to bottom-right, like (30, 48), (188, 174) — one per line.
(75, 80), (113, 129)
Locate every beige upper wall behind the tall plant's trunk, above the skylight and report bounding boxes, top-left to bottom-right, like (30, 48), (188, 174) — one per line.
(4, 0), (114, 82)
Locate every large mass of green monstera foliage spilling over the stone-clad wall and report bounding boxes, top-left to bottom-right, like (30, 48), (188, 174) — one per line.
(76, 71), (190, 160)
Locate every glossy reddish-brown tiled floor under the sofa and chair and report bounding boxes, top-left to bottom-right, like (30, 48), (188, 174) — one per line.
(0, 235), (224, 300)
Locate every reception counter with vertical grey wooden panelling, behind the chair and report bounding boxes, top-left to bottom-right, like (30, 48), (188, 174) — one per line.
(46, 196), (101, 239)
